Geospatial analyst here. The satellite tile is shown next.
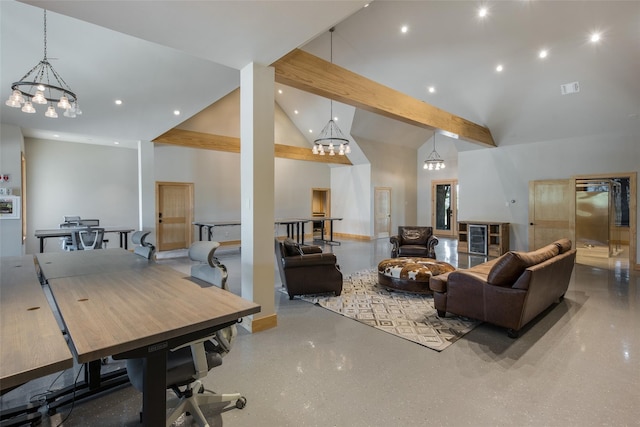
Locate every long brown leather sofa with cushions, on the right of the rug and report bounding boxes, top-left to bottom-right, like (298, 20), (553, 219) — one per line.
(429, 239), (576, 338)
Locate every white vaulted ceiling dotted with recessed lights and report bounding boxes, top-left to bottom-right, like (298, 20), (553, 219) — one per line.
(0, 0), (640, 154)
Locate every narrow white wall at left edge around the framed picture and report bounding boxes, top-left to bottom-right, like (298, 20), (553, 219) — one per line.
(0, 125), (25, 256)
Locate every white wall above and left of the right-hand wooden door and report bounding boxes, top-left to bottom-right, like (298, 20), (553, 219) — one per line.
(458, 134), (640, 258)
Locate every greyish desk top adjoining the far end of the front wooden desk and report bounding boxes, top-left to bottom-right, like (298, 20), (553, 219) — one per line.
(36, 248), (155, 280)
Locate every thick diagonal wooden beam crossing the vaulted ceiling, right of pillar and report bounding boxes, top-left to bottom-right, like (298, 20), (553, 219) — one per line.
(272, 49), (496, 147)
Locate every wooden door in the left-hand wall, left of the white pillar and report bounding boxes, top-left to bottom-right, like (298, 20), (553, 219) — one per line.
(156, 182), (193, 251)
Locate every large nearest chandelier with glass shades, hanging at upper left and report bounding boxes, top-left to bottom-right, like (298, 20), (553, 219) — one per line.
(5, 10), (82, 119)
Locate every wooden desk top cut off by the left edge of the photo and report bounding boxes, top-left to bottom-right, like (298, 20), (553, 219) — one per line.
(0, 255), (73, 390)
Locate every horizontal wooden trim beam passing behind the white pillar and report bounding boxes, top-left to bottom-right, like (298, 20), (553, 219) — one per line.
(153, 128), (353, 166)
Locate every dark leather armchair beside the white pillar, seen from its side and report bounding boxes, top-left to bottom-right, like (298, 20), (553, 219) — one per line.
(275, 238), (342, 299)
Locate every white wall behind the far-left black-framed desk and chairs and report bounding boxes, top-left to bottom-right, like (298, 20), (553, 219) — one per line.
(25, 138), (138, 254)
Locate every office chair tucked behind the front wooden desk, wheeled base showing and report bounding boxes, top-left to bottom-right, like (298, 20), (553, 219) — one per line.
(126, 242), (247, 427)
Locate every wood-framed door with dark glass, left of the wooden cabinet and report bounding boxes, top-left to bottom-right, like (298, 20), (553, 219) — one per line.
(431, 180), (458, 236)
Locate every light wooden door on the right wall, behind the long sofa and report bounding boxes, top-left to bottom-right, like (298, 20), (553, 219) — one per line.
(529, 179), (575, 250)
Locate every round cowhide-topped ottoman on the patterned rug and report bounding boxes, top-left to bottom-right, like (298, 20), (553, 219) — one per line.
(378, 258), (455, 294)
